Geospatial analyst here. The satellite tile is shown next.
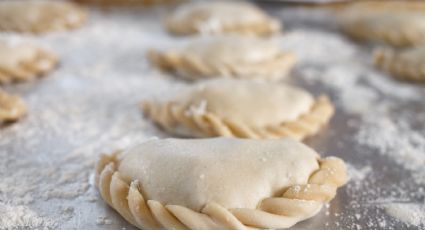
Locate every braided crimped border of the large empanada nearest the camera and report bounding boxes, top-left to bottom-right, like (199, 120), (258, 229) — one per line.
(96, 139), (347, 230)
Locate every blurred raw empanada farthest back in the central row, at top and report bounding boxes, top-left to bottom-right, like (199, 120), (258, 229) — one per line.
(166, 1), (281, 35)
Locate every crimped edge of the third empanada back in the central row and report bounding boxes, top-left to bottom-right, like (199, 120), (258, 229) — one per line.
(147, 49), (296, 80)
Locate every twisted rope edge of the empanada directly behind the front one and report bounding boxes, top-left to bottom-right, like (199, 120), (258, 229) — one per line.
(141, 96), (335, 140)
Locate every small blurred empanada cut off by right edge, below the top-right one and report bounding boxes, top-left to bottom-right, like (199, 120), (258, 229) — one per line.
(374, 46), (425, 81)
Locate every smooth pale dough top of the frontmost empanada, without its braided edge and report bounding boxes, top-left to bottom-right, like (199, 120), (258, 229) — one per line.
(118, 138), (319, 211)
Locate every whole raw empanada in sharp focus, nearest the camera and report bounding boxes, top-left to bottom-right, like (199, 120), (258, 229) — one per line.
(96, 138), (347, 230)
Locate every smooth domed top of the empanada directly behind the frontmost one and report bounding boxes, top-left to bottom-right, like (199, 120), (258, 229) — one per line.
(176, 80), (314, 127)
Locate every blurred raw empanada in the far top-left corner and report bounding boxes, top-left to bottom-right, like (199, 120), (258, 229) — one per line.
(0, 0), (87, 33)
